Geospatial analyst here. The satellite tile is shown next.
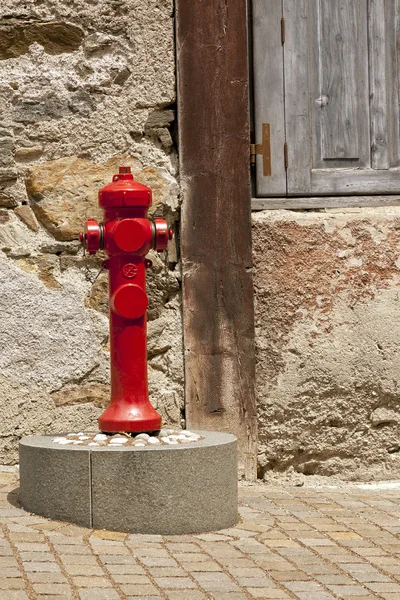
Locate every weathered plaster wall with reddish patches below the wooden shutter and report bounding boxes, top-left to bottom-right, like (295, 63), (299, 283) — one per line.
(253, 208), (400, 480)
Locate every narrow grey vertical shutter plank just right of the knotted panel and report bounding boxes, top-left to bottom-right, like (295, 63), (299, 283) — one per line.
(368, 0), (393, 169)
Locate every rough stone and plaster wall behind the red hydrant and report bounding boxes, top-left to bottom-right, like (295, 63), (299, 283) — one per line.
(0, 0), (183, 462)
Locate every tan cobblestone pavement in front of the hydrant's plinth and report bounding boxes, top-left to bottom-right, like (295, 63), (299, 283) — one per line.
(0, 468), (400, 600)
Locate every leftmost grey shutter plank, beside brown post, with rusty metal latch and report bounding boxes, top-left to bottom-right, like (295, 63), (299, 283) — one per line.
(253, 0), (286, 196)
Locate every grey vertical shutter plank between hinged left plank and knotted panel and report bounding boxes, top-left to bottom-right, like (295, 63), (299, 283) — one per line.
(283, 0), (311, 194)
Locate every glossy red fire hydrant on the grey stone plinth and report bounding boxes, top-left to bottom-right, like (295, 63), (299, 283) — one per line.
(80, 167), (172, 433)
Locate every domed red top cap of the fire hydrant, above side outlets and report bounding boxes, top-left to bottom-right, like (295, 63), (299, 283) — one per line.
(99, 167), (152, 208)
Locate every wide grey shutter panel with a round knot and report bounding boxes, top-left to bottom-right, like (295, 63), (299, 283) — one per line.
(310, 0), (370, 168)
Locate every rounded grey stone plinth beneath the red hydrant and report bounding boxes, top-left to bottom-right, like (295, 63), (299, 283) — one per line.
(20, 431), (238, 535)
